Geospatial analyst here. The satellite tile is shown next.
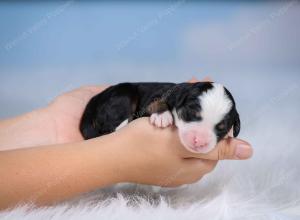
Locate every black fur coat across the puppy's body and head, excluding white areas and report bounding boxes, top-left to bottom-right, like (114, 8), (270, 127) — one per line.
(80, 82), (240, 140)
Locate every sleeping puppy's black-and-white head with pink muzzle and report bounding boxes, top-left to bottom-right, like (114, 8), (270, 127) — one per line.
(173, 82), (240, 153)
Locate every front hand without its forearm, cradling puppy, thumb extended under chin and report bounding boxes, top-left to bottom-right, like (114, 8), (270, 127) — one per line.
(117, 118), (252, 187)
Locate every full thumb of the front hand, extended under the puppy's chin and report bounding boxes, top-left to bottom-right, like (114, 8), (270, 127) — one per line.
(185, 137), (253, 160)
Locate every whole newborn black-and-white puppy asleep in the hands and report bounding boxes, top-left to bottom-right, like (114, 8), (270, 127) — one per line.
(80, 82), (240, 153)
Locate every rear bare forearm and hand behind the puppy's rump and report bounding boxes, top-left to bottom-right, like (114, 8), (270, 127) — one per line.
(0, 86), (106, 151)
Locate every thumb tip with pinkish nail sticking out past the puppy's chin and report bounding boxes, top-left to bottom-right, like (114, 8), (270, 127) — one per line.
(216, 137), (253, 160)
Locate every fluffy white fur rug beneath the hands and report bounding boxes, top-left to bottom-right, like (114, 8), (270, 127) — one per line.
(0, 104), (300, 220)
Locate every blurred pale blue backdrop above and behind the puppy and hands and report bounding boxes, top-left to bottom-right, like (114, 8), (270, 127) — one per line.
(0, 0), (300, 133)
